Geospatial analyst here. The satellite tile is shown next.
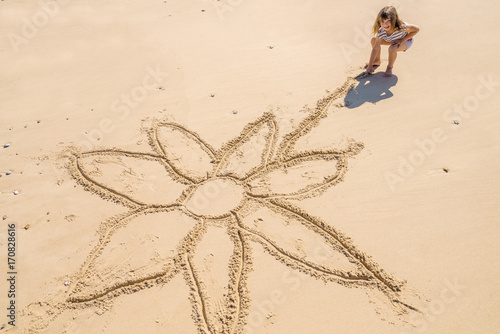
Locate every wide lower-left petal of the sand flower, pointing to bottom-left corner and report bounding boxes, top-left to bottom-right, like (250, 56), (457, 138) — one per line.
(68, 205), (200, 303)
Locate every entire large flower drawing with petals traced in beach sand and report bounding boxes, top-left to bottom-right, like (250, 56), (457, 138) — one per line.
(20, 78), (418, 333)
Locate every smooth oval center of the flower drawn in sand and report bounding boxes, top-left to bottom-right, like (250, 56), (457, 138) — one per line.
(185, 178), (244, 217)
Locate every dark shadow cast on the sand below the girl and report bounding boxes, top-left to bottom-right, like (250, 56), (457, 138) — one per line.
(344, 72), (398, 109)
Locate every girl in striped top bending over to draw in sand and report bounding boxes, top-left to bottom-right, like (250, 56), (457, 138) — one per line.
(366, 6), (420, 77)
